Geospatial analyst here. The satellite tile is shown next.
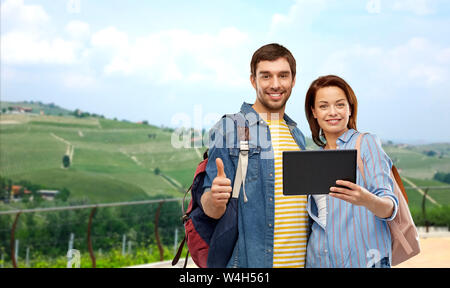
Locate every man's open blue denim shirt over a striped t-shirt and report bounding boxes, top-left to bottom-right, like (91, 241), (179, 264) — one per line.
(203, 103), (305, 268)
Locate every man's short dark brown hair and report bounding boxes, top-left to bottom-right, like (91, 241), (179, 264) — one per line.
(250, 43), (296, 79)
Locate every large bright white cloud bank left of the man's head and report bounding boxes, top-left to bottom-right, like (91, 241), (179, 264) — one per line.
(1, 0), (249, 87)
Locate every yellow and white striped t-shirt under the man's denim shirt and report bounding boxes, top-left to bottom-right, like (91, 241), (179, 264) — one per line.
(267, 120), (308, 268)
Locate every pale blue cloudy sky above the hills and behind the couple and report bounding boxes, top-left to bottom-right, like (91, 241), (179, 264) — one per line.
(0, 0), (450, 144)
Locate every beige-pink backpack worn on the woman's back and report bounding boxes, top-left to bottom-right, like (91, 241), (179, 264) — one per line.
(356, 134), (420, 266)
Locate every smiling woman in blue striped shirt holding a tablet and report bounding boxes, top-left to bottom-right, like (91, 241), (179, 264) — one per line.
(305, 75), (398, 267)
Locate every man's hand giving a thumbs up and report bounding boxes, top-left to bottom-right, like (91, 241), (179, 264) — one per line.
(200, 158), (233, 219)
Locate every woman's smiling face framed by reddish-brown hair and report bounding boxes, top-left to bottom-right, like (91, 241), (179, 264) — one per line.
(311, 86), (351, 136)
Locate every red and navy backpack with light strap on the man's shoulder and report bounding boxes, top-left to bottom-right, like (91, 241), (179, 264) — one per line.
(172, 114), (249, 268)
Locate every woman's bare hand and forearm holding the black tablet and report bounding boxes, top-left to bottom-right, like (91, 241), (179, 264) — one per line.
(329, 180), (394, 218)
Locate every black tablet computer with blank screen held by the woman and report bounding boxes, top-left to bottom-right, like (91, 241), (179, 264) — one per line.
(283, 149), (357, 195)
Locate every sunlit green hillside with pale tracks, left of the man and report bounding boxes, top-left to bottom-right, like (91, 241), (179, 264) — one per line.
(0, 114), (200, 203)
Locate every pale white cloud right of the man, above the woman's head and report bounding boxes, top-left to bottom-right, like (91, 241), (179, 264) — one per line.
(319, 37), (450, 87)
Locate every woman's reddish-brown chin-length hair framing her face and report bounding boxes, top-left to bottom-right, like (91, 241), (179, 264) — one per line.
(305, 75), (358, 147)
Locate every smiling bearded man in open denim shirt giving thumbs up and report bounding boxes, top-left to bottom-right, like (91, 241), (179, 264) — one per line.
(201, 44), (308, 267)
